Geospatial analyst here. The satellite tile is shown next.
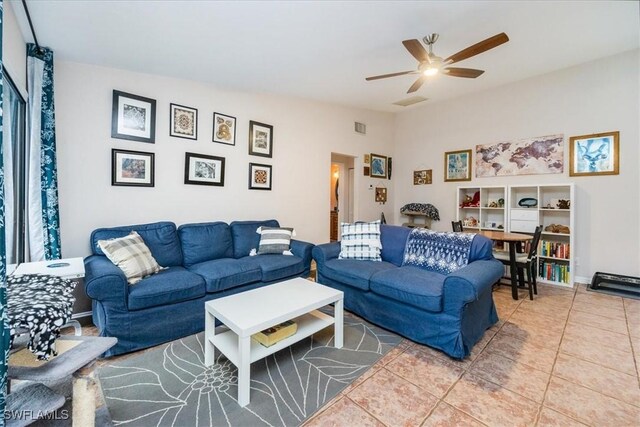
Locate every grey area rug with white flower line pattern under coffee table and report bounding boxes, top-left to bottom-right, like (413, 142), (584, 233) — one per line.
(98, 312), (402, 426)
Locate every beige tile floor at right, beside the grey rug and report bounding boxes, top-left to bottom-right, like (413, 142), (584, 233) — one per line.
(305, 285), (640, 427)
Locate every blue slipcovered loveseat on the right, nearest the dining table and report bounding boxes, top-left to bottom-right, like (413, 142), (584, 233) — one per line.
(313, 225), (503, 359)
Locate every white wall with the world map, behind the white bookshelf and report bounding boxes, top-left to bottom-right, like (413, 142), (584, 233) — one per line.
(394, 50), (640, 278)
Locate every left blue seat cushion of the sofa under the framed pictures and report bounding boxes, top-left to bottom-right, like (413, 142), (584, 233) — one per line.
(128, 267), (205, 310)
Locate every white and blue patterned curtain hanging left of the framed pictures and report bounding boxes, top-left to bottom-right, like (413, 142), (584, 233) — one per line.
(27, 43), (60, 261)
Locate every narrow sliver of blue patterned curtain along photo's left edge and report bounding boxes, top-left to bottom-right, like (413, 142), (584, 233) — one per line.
(0, 0), (9, 426)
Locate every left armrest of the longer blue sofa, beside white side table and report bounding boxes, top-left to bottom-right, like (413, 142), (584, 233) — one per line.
(84, 255), (129, 307)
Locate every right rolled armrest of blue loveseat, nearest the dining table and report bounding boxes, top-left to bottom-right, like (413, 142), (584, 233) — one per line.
(443, 259), (504, 310)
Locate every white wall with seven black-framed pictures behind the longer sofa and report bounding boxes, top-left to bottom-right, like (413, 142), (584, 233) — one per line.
(55, 61), (394, 257)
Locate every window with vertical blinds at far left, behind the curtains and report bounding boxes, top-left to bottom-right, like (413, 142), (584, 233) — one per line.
(2, 73), (27, 264)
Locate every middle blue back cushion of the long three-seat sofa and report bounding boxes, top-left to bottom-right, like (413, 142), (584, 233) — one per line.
(178, 221), (233, 267)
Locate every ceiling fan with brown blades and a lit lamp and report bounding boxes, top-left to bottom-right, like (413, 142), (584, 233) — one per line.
(366, 33), (509, 93)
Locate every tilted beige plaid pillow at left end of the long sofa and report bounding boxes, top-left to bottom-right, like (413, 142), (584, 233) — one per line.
(98, 231), (162, 285)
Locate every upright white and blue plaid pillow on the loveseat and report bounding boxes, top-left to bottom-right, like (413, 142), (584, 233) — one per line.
(338, 221), (382, 261)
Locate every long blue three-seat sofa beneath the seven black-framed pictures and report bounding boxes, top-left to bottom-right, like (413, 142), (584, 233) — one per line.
(84, 220), (313, 356)
